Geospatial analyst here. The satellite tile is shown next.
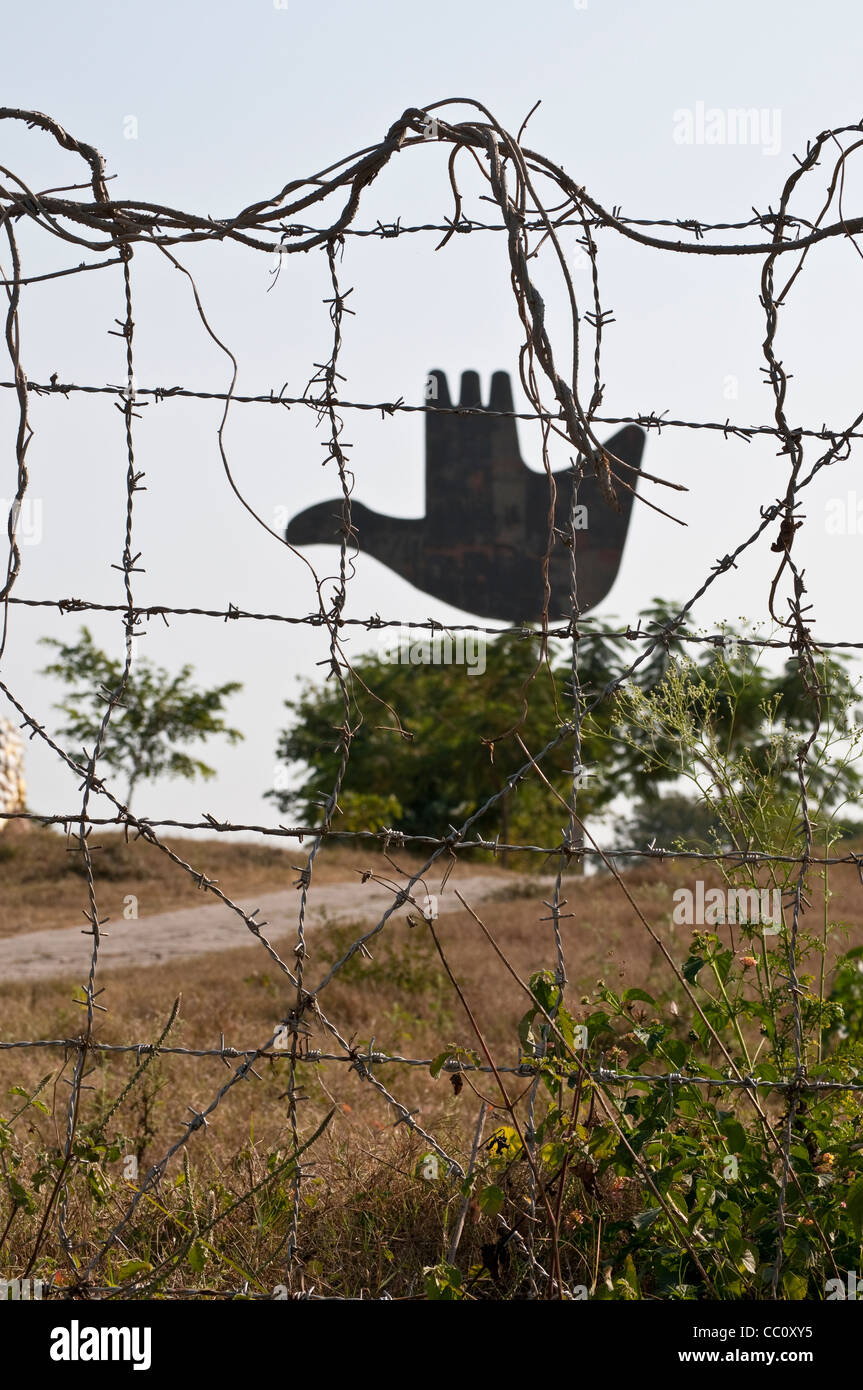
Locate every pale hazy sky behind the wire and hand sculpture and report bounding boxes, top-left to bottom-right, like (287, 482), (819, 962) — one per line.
(0, 0), (863, 823)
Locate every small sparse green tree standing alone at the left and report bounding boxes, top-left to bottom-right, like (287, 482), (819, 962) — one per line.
(42, 627), (243, 806)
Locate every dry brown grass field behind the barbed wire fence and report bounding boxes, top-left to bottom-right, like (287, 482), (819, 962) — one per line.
(0, 831), (863, 1291)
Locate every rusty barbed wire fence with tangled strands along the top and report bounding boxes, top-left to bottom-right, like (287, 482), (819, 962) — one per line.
(0, 100), (863, 1295)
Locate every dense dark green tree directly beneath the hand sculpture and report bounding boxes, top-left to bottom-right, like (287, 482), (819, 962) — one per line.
(268, 634), (644, 844)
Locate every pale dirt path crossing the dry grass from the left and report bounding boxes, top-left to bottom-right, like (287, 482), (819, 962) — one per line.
(0, 874), (542, 983)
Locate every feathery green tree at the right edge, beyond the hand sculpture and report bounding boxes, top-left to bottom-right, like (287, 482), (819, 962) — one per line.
(614, 622), (863, 849)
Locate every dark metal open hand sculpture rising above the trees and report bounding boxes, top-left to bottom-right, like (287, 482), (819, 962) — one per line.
(286, 371), (645, 623)
